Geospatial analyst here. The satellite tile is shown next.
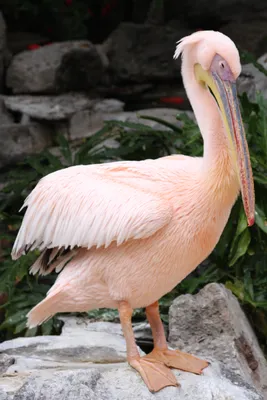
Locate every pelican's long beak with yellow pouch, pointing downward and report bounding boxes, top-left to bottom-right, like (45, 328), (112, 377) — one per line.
(195, 64), (255, 226)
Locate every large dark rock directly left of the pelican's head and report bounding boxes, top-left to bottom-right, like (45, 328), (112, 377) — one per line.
(107, 22), (189, 84)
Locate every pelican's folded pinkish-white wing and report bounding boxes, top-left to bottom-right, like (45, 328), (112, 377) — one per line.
(12, 164), (173, 259)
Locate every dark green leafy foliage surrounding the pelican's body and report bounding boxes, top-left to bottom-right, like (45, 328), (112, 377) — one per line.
(0, 78), (267, 356)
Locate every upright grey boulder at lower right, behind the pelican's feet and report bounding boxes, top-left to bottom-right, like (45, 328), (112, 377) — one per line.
(169, 283), (267, 398)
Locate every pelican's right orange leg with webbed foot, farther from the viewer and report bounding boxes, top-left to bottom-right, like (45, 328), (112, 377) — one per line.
(146, 302), (209, 374)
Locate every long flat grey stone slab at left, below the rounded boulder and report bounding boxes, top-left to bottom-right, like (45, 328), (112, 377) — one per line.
(4, 93), (95, 121)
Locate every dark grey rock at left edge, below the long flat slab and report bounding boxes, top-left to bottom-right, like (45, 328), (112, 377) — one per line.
(0, 123), (52, 168)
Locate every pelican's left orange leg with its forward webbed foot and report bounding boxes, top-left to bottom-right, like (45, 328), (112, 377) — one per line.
(118, 301), (178, 392)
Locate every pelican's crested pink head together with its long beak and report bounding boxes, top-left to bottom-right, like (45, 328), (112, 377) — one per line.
(174, 31), (255, 226)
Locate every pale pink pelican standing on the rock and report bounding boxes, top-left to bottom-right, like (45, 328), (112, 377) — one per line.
(12, 31), (255, 392)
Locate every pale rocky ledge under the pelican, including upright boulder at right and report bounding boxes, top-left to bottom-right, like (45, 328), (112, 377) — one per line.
(0, 284), (267, 400)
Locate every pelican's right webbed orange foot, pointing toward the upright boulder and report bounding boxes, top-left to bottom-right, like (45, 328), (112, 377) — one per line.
(144, 348), (209, 375)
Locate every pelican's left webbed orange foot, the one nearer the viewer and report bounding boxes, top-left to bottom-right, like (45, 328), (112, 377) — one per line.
(129, 356), (180, 393)
